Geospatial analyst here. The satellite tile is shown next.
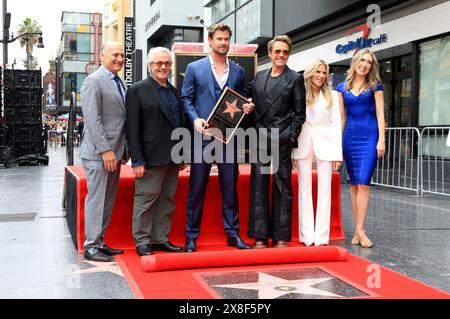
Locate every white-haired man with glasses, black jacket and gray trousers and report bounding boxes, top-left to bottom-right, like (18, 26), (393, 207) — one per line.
(126, 47), (184, 256)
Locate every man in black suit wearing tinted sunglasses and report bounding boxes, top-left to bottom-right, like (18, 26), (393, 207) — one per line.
(247, 36), (306, 248)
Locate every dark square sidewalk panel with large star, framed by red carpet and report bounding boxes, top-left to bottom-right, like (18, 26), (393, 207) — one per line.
(195, 266), (370, 299)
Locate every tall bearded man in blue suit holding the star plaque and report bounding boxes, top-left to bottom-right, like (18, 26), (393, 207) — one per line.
(181, 24), (254, 252)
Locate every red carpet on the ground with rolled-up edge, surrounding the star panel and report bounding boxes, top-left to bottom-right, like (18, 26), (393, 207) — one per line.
(116, 246), (450, 299)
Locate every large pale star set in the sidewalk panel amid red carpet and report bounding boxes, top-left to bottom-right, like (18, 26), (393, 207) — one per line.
(214, 272), (343, 299)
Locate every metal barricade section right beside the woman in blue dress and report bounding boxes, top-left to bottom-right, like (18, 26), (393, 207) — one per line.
(372, 127), (422, 195)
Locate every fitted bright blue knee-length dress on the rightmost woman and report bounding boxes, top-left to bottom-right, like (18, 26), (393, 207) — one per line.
(336, 82), (383, 185)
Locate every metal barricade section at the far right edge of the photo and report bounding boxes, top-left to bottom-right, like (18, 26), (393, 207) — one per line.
(421, 126), (450, 196)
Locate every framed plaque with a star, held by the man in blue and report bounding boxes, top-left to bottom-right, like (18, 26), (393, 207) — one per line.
(206, 87), (248, 144)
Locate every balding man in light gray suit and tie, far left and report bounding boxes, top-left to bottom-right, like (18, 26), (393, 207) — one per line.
(80, 42), (127, 262)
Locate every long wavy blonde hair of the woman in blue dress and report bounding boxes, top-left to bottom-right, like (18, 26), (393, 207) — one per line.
(344, 49), (381, 91)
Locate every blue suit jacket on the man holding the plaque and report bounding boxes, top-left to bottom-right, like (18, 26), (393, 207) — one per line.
(181, 56), (244, 124)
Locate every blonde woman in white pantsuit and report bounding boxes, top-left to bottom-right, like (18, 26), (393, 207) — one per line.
(292, 59), (342, 246)
